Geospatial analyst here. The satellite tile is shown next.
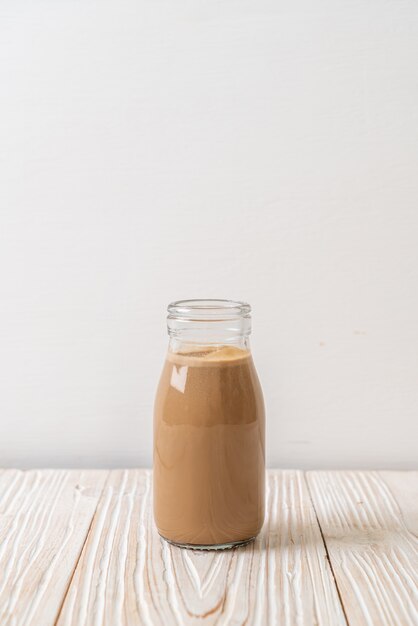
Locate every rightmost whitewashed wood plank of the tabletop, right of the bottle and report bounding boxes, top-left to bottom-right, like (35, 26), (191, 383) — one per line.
(307, 472), (418, 626)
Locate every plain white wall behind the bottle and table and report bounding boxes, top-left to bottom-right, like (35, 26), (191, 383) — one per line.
(0, 0), (418, 468)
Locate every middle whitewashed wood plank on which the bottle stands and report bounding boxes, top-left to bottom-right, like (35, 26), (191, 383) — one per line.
(58, 470), (345, 626)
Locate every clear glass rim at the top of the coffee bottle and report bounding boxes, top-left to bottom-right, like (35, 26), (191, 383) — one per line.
(167, 299), (251, 322)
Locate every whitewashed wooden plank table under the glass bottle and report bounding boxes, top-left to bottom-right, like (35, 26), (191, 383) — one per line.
(0, 470), (418, 626)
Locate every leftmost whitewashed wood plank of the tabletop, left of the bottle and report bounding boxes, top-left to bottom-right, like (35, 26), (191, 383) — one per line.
(0, 470), (107, 626)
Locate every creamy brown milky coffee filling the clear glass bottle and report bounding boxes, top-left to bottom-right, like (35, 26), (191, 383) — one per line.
(154, 346), (264, 546)
